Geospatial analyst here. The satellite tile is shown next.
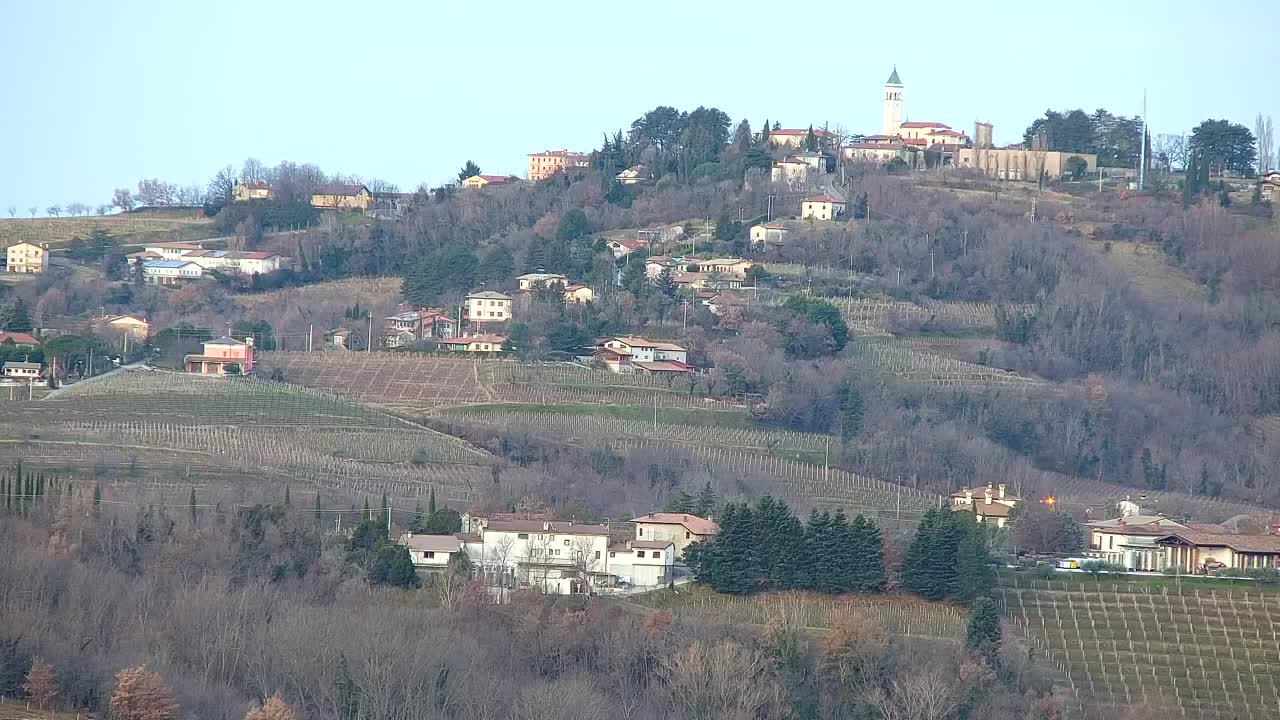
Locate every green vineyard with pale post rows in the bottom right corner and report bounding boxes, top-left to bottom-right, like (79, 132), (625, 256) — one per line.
(1000, 580), (1280, 720)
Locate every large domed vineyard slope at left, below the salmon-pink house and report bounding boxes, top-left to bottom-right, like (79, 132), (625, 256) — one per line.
(0, 372), (492, 502)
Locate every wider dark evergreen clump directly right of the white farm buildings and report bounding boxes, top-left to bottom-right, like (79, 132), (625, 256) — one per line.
(685, 497), (884, 593)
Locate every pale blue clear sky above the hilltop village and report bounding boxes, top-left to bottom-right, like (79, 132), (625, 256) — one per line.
(0, 0), (1280, 210)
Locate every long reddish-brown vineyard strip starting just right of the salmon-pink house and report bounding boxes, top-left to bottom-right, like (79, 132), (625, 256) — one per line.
(259, 352), (727, 410)
